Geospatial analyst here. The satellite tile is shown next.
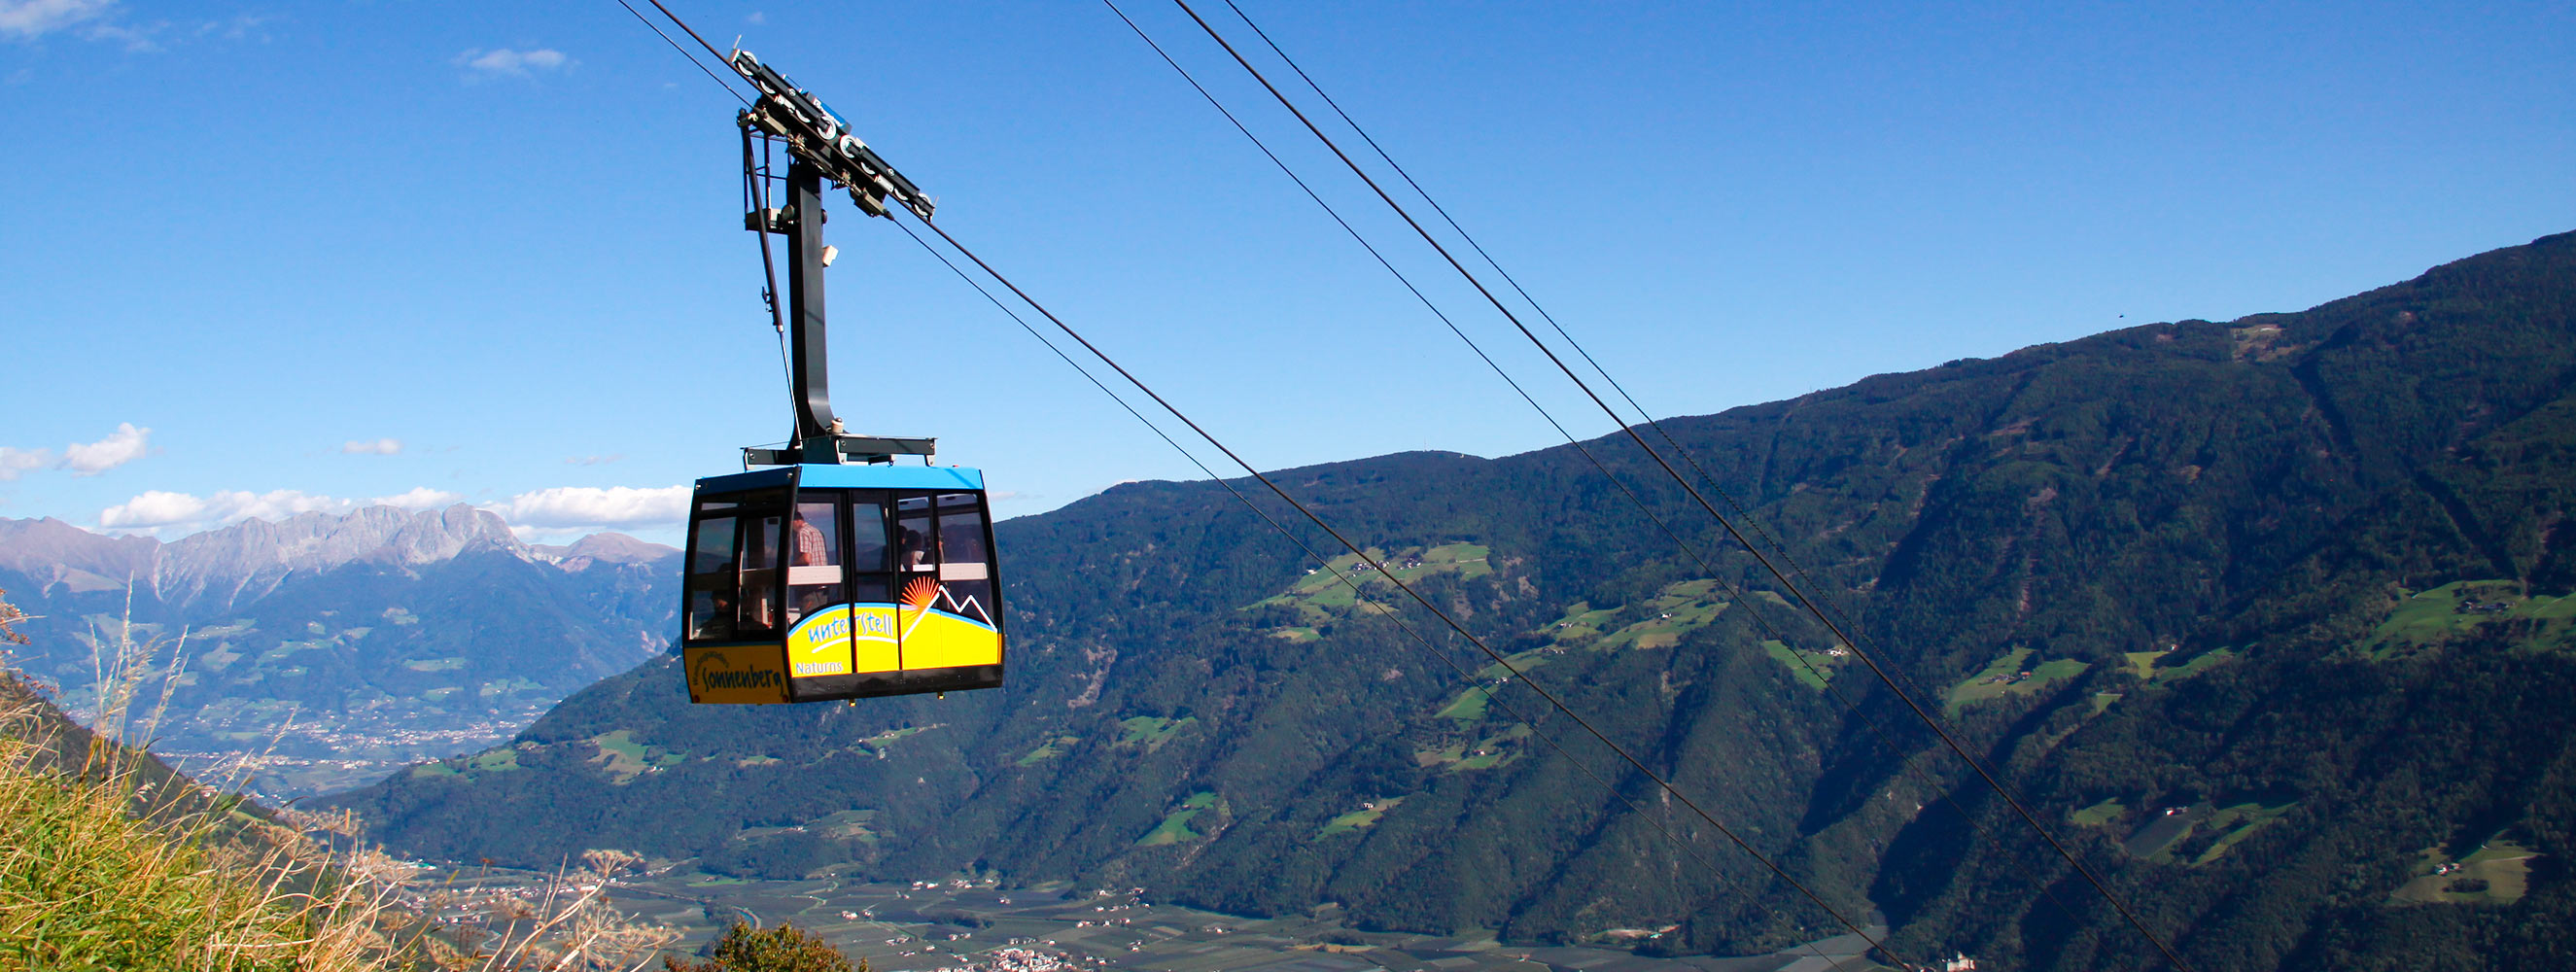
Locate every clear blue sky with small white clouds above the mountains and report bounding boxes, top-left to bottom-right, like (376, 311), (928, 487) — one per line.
(0, 0), (2576, 541)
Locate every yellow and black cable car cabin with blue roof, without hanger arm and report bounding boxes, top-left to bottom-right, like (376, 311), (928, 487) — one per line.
(680, 464), (1002, 704)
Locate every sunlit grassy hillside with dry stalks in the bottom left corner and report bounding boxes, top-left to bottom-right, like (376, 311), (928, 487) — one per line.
(0, 598), (726, 972)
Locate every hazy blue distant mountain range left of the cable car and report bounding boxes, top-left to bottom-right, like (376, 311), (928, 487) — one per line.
(0, 505), (678, 797)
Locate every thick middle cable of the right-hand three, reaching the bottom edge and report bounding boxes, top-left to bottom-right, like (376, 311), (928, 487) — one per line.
(1172, 0), (2190, 972)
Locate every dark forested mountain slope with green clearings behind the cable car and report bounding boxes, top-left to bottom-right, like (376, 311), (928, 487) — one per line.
(327, 234), (2576, 969)
